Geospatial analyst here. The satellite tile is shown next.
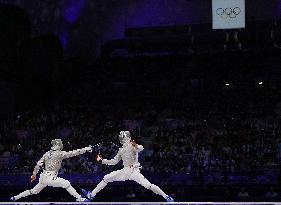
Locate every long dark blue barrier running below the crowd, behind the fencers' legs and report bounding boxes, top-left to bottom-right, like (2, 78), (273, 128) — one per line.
(0, 170), (279, 186)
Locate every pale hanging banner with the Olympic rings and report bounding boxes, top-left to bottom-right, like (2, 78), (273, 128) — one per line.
(212, 0), (245, 29)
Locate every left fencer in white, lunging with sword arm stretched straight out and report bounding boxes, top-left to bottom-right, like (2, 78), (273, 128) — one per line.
(11, 139), (92, 202)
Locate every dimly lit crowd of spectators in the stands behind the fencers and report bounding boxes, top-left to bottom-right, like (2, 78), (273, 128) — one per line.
(0, 83), (281, 181)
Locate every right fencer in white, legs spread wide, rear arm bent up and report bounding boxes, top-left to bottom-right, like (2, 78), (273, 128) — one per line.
(82, 131), (174, 202)
